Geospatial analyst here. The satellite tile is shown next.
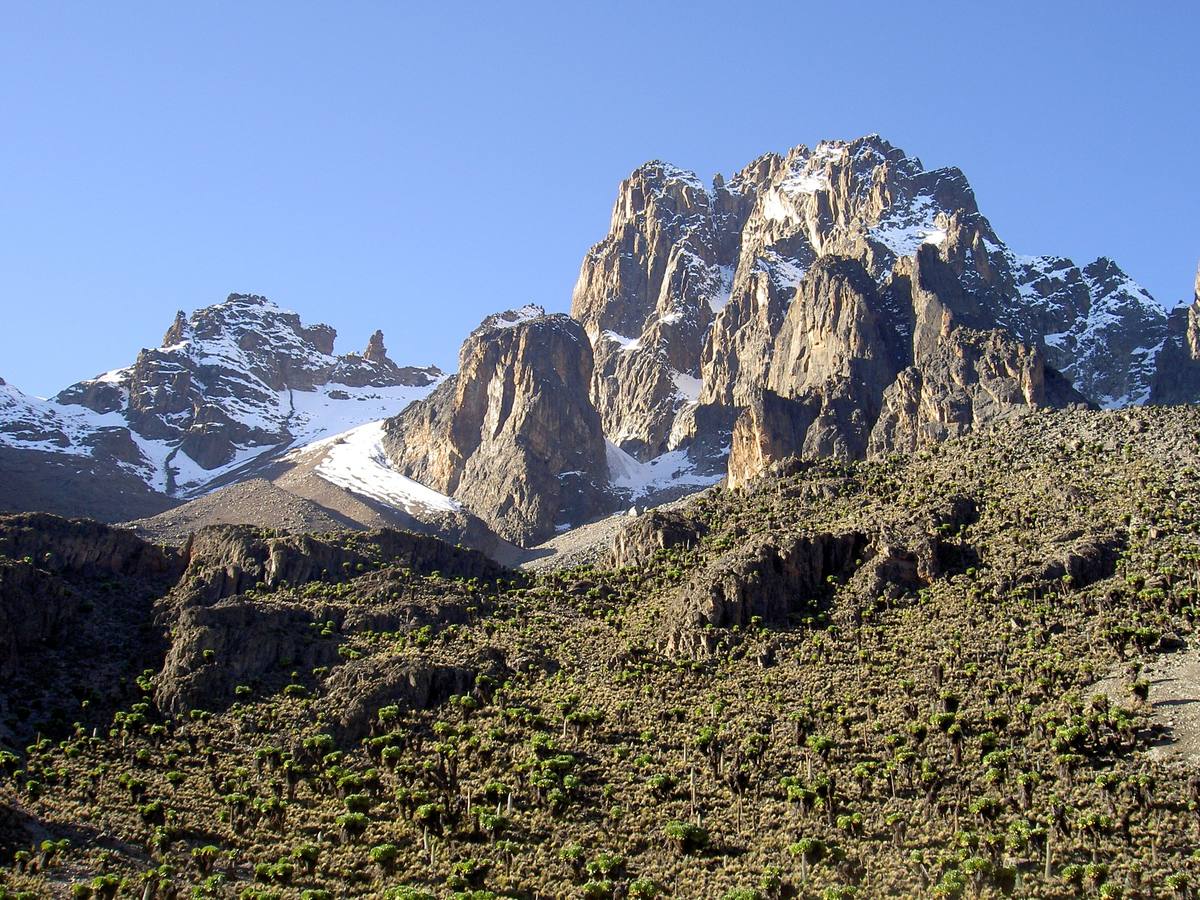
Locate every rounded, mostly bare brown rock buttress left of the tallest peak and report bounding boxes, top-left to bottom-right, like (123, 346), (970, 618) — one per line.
(384, 306), (607, 544)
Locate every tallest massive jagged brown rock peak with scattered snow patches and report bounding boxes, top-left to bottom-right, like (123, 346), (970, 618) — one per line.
(572, 136), (1166, 489)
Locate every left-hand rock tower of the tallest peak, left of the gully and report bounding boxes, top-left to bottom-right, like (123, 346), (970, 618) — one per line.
(571, 162), (748, 460)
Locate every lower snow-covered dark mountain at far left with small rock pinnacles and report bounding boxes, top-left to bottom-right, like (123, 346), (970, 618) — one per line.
(0, 294), (442, 520)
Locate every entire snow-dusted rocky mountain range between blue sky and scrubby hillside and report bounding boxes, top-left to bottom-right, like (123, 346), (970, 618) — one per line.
(0, 136), (1200, 558)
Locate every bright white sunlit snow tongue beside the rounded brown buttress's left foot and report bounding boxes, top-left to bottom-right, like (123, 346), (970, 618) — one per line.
(314, 421), (463, 515)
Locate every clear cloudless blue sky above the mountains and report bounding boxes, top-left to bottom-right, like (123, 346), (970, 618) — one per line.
(0, 0), (1200, 395)
